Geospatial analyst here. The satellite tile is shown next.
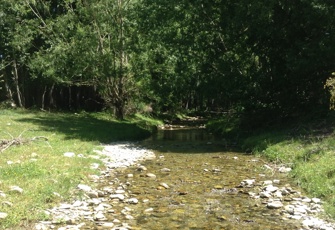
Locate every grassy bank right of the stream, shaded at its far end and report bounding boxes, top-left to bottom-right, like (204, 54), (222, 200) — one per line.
(208, 115), (335, 219)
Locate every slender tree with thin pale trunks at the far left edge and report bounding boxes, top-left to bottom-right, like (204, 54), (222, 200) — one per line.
(0, 0), (36, 107)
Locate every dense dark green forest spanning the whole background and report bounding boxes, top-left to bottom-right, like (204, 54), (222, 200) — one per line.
(0, 0), (335, 124)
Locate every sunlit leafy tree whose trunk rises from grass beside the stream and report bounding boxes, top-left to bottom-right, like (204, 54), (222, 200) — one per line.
(30, 0), (139, 119)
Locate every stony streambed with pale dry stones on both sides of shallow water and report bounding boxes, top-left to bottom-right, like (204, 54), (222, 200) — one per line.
(35, 142), (335, 230)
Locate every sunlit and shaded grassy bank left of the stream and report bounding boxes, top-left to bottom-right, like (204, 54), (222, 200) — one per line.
(0, 110), (161, 229)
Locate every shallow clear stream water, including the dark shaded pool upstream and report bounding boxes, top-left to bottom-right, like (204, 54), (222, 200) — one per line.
(105, 127), (301, 230)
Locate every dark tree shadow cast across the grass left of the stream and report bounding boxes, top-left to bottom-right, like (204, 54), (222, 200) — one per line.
(17, 113), (150, 144)
